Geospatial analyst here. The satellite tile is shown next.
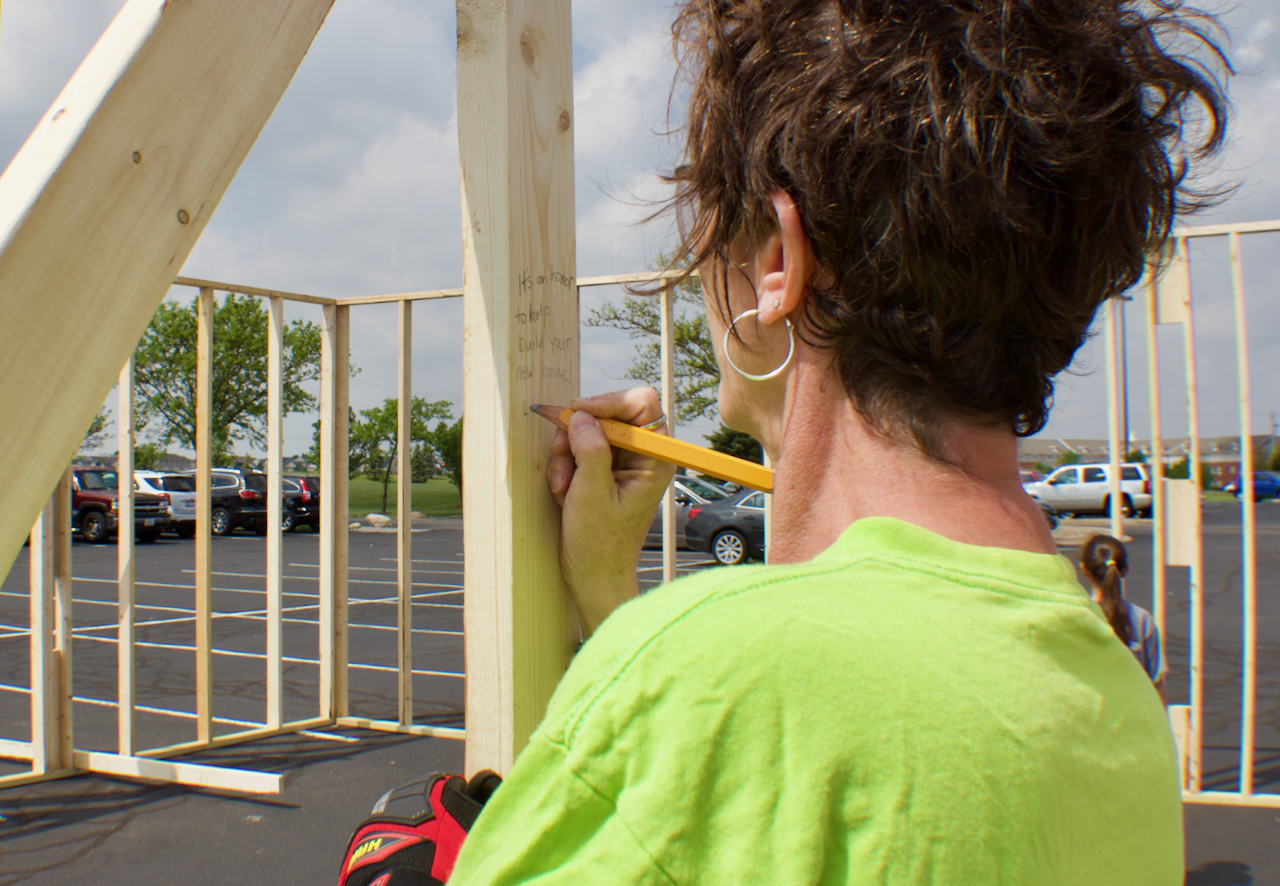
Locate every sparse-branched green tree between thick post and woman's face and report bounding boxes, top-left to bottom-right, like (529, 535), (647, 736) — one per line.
(585, 262), (719, 423)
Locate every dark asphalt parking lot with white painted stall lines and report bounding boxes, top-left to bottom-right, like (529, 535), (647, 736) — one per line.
(0, 503), (1280, 886)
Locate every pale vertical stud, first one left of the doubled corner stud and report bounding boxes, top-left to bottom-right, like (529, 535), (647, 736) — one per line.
(266, 296), (284, 729)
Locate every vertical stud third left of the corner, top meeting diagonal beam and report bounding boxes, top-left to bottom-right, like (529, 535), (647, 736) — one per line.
(115, 355), (136, 754)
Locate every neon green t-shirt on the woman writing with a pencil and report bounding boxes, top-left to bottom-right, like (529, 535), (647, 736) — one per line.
(451, 519), (1183, 886)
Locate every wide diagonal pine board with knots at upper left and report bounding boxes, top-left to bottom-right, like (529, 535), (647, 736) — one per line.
(0, 0), (333, 581)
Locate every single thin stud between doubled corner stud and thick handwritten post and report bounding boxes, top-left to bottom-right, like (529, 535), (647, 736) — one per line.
(396, 301), (413, 726)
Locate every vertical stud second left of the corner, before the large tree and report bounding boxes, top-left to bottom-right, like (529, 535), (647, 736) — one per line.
(196, 287), (214, 741)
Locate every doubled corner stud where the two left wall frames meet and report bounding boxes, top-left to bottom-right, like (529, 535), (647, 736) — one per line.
(319, 305), (351, 718)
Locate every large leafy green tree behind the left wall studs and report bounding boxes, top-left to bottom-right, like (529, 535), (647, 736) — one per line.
(134, 293), (335, 463)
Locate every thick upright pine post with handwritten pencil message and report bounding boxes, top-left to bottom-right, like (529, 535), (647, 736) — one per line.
(457, 0), (579, 773)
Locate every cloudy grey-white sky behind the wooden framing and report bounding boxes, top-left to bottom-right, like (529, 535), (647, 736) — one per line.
(0, 0), (1280, 453)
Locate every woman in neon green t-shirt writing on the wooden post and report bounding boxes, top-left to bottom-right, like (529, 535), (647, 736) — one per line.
(454, 0), (1225, 886)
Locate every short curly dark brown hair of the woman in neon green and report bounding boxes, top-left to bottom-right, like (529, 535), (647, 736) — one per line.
(668, 0), (1230, 462)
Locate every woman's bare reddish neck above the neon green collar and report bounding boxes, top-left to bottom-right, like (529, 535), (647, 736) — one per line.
(760, 373), (1057, 563)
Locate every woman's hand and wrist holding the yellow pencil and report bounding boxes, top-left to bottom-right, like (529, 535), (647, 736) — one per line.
(547, 388), (676, 636)
